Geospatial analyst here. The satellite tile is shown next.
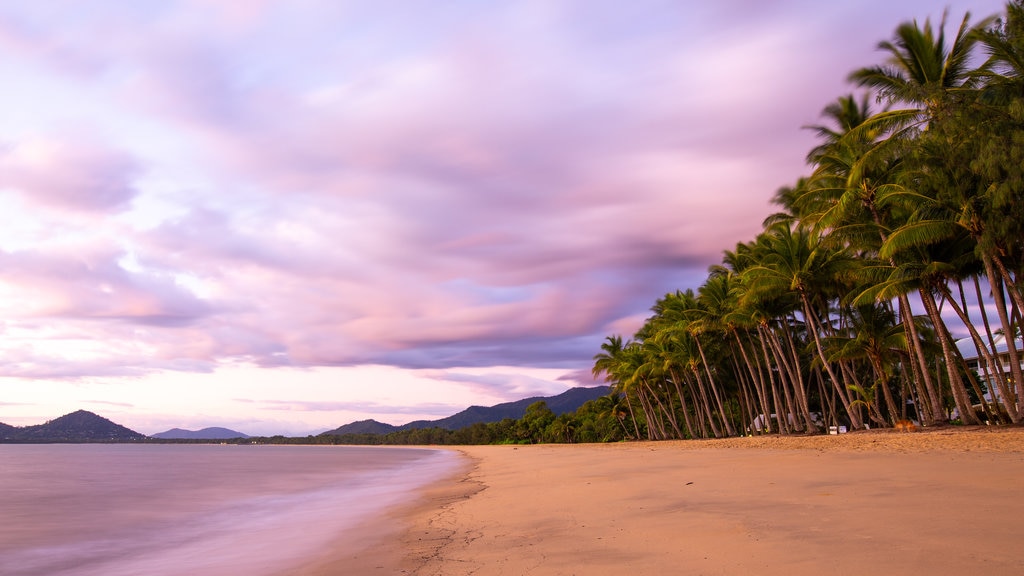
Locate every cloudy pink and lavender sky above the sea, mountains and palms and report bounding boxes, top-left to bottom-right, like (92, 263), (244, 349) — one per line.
(0, 0), (1004, 436)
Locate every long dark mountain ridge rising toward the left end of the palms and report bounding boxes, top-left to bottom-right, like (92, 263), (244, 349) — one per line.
(323, 386), (611, 435)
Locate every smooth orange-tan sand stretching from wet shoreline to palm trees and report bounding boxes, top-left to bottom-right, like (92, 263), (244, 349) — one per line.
(395, 428), (1024, 576)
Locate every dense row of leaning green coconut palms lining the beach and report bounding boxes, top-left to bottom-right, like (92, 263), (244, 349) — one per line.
(593, 0), (1024, 439)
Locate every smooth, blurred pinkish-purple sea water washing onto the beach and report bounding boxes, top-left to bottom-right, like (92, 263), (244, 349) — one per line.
(0, 445), (458, 576)
